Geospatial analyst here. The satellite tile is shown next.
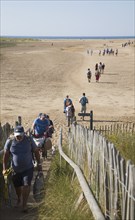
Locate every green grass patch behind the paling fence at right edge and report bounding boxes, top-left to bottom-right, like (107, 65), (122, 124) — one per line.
(107, 133), (135, 164)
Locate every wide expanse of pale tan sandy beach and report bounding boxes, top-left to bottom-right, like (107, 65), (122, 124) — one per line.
(0, 39), (135, 134)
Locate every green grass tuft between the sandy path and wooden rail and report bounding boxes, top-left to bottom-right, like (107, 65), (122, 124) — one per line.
(38, 152), (94, 220)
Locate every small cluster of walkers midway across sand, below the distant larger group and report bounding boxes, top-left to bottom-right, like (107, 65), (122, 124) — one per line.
(87, 62), (105, 83)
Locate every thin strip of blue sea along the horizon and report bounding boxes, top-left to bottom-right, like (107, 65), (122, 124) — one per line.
(1, 36), (135, 40)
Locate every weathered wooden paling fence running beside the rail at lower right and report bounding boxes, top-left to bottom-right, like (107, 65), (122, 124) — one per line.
(69, 124), (135, 220)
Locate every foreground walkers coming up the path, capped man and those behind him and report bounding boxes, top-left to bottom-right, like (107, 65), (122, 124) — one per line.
(2, 113), (54, 212)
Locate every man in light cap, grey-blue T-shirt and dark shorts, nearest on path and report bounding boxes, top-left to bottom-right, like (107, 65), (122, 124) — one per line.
(3, 126), (42, 212)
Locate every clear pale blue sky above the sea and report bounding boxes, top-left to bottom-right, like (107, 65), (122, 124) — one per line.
(0, 0), (135, 37)
